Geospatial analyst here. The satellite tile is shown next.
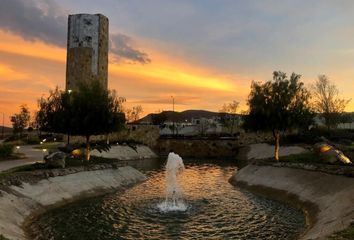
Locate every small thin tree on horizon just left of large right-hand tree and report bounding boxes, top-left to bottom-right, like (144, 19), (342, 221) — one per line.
(219, 101), (240, 135)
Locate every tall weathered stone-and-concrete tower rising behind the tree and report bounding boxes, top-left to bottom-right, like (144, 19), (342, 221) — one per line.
(66, 14), (108, 90)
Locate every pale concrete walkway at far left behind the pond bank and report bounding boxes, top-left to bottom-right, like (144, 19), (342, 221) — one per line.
(0, 145), (47, 172)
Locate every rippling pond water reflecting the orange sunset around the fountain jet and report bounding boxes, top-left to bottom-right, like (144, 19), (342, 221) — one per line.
(31, 159), (305, 240)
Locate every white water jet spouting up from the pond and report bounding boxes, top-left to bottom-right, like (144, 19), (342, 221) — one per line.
(157, 152), (187, 212)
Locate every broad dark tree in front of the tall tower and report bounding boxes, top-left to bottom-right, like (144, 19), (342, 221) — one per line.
(38, 81), (125, 160)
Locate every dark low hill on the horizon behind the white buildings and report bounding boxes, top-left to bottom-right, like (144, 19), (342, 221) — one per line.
(137, 110), (238, 123)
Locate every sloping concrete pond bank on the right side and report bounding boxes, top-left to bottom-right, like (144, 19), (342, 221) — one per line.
(229, 164), (354, 239)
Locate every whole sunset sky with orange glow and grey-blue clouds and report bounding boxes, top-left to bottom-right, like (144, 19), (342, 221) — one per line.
(0, 0), (354, 126)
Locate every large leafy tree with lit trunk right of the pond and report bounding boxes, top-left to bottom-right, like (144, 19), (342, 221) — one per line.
(244, 71), (313, 160)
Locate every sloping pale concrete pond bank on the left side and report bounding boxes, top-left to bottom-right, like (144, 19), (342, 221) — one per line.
(0, 164), (146, 240)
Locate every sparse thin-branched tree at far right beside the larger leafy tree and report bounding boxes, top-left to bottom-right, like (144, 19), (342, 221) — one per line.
(312, 75), (350, 131)
